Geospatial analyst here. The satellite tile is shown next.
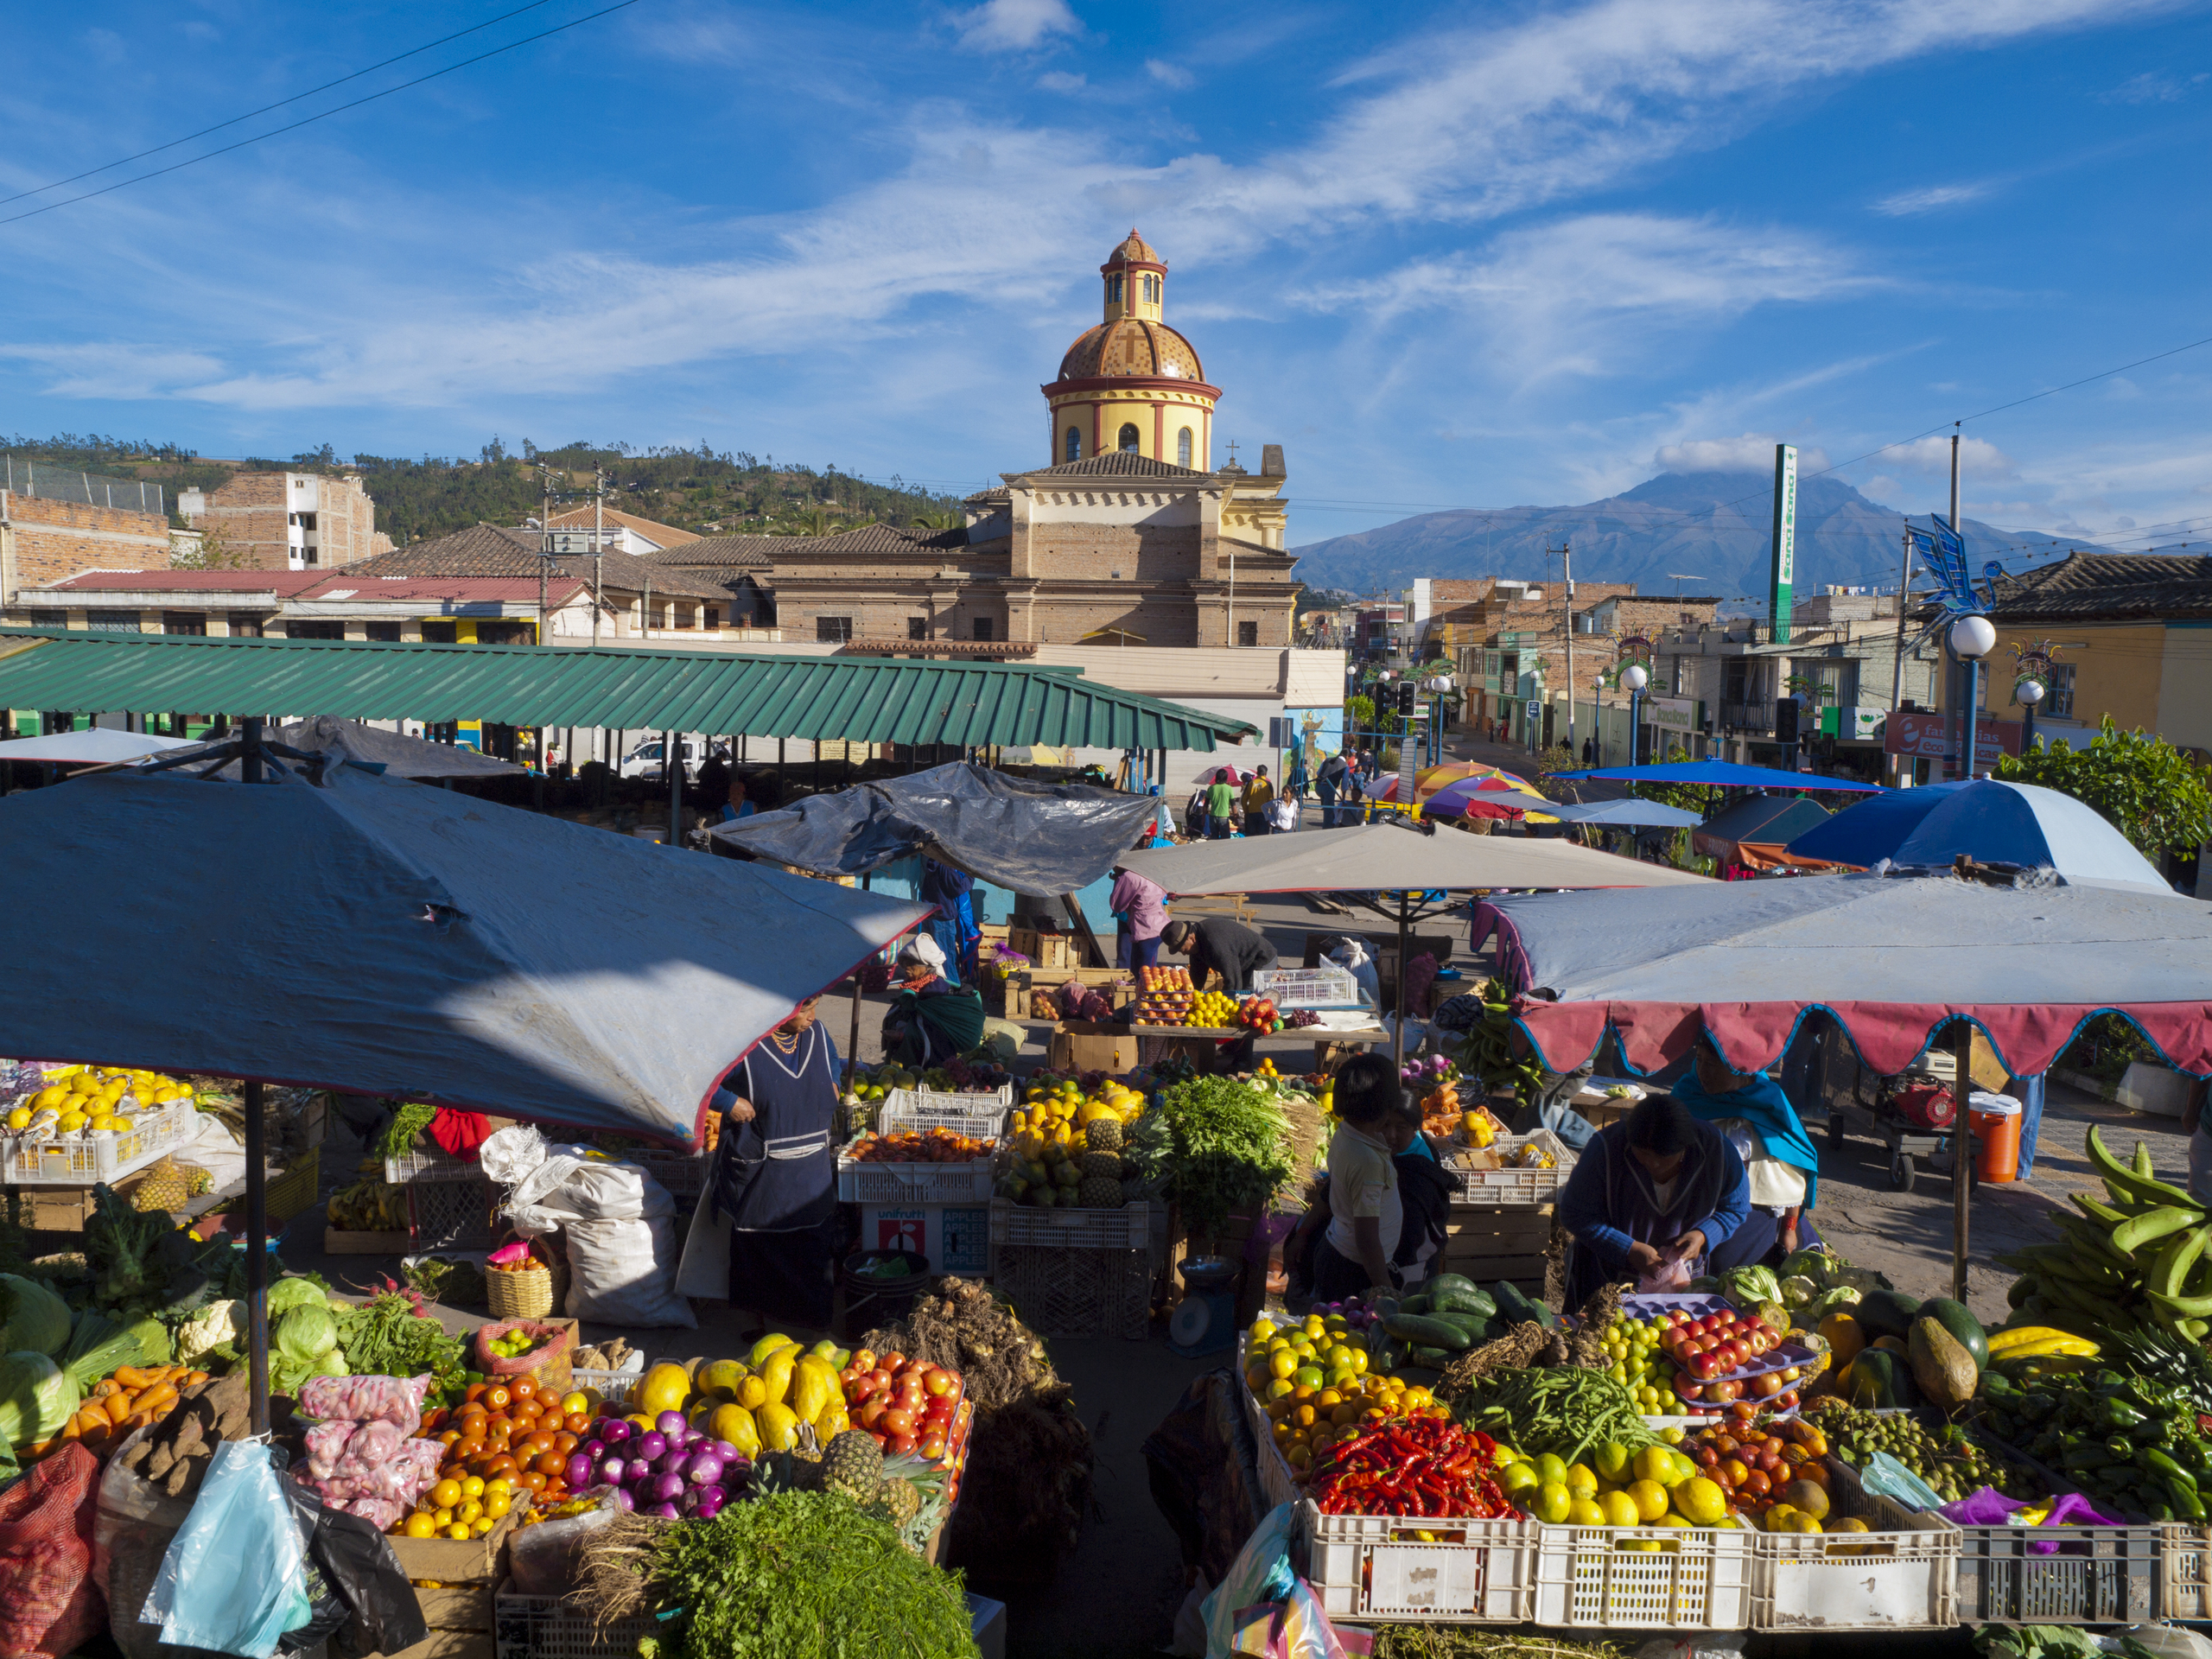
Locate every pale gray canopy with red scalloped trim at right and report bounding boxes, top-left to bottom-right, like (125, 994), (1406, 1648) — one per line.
(1476, 874), (2212, 1077)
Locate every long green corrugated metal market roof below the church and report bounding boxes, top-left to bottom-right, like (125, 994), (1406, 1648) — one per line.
(0, 628), (1259, 750)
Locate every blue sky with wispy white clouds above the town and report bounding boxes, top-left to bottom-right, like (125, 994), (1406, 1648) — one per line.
(0, 0), (2212, 559)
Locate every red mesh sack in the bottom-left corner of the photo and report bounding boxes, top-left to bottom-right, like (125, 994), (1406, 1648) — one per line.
(0, 1440), (108, 1659)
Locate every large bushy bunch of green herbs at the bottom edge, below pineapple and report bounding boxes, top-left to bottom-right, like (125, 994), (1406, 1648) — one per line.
(646, 1491), (976, 1659)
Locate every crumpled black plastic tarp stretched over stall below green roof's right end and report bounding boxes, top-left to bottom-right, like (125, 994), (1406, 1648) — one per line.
(710, 761), (1159, 898)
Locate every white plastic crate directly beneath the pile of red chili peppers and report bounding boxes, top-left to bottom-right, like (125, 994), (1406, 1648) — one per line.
(1299, 1502), (1535, 1624)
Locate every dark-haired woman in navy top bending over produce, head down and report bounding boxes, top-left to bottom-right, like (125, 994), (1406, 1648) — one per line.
(1560, 1095), (1750, 1307)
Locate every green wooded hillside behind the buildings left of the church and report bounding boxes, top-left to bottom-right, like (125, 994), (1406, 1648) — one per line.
(0, 434), (960, 546)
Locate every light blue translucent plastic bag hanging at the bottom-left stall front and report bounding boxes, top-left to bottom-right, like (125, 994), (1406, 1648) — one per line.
(146, 1440), (309, 1659)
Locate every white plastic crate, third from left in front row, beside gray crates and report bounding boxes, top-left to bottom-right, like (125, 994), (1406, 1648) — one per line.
(1752, 1458), (1960, 1630)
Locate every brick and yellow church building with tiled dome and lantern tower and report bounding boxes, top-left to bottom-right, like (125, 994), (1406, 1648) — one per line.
(648, 230), (1296, 657)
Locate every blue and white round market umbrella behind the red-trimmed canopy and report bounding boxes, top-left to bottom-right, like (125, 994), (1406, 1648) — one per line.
(1789, 779), (2172, 893)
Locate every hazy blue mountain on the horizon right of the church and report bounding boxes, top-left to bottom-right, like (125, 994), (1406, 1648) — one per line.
(1292, 471), (2086, 606)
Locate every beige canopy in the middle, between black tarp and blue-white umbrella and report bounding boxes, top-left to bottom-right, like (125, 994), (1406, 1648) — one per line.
(1122, 823), (1714, 898)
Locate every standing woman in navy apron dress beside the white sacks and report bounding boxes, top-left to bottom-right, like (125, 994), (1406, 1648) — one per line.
(715, 998), (836, 1332)
